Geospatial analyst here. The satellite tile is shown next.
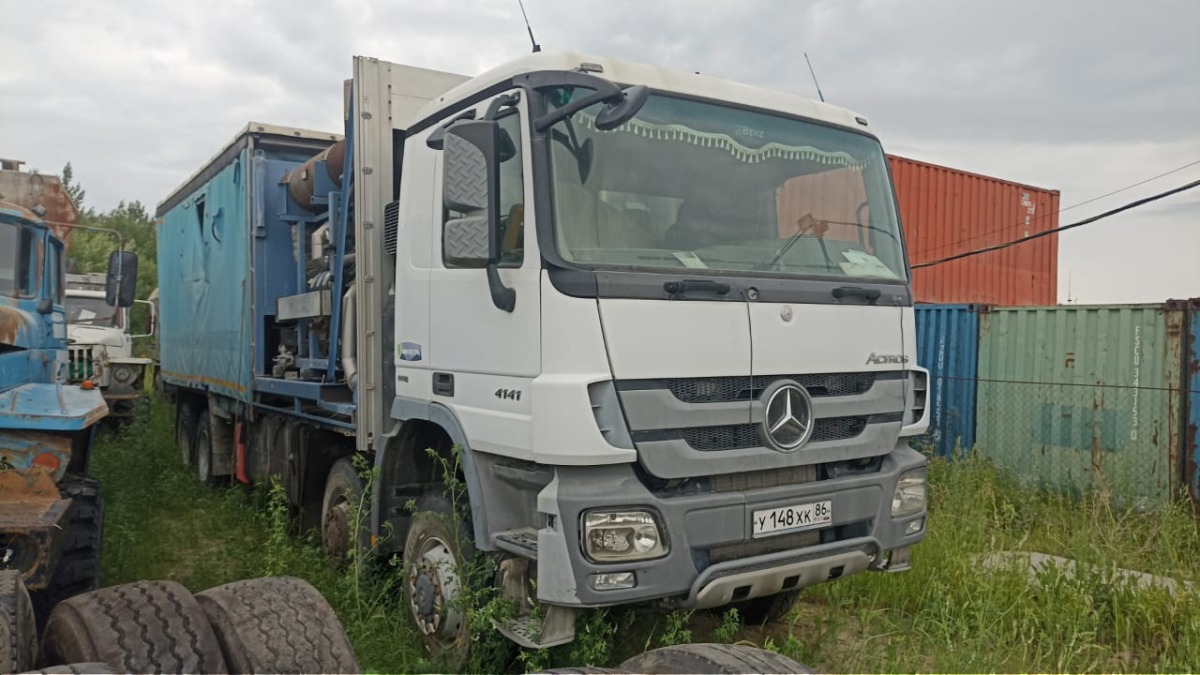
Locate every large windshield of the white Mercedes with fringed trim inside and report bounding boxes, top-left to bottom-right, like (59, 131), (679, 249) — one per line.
(551, 90), (906, 281)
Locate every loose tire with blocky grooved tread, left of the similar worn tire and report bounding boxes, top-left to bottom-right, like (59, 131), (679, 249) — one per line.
(41, 581), (227, 673)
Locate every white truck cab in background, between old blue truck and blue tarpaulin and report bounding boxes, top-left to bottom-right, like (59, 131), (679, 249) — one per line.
(66, 274), (155, 418)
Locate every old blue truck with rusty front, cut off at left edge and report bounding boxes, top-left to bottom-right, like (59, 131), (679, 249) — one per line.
(0, 196), (137, 638)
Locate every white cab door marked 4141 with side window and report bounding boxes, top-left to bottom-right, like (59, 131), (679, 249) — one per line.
(424, 89), (541, 458)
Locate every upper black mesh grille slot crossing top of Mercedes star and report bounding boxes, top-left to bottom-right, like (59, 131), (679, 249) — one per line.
(662, 372), (876, 404)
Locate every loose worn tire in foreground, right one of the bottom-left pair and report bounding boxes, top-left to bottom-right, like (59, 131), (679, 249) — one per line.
(196, 577), (359, 673)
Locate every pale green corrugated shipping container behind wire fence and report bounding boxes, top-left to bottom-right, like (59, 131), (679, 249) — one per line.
(976, 301), (1186, 508)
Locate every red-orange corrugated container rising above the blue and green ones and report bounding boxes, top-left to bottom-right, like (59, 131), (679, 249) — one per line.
(888, 155), (1058, 306)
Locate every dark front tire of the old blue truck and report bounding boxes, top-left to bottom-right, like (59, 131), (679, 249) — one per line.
(30, 473), (104, 632)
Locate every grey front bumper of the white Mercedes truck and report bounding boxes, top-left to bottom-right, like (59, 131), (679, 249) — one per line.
(538, 440), (926, 608)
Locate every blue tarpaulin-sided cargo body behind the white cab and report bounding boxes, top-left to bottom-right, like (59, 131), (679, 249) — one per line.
(158, 125), (337, 402)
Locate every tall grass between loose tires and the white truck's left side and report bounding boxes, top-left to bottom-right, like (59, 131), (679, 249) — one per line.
(92, 401), (433, 673)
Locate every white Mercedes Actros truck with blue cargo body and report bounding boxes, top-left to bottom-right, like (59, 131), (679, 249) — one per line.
(158, 53), (928, 649)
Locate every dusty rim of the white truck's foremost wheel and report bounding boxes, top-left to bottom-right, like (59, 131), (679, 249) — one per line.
(408, 537), (463, 645)
